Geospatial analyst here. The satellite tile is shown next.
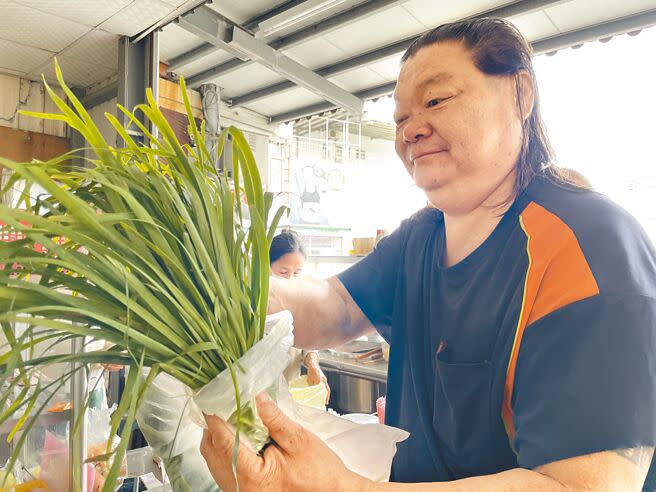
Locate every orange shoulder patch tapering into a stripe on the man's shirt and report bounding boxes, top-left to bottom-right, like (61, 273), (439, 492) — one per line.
(501, 202), (599, 443)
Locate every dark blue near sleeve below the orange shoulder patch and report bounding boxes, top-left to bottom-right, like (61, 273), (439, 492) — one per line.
(513, 294), (656, 468)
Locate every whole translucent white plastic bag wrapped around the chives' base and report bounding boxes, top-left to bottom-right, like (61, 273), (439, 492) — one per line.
(137, 311), (409, 492)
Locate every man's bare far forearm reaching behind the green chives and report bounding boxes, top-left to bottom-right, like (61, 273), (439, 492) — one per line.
(269, 277), (374, 349)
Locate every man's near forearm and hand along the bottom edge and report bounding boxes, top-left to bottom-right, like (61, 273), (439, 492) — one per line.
(201, 395), (654, 492)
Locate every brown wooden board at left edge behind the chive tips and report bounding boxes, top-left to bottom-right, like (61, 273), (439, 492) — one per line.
(0, 126), (71, 162)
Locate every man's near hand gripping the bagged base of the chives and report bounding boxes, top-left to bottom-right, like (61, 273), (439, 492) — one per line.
(200, 394), (370, 492)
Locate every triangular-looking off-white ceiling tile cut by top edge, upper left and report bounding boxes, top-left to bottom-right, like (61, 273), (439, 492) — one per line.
(15, 0), (134, 27)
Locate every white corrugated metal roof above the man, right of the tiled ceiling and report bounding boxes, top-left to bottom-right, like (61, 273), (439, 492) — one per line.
(162, 0), (656, 122)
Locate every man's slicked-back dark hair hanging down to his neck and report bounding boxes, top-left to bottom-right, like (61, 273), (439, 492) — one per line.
(401, 17), (568, 193)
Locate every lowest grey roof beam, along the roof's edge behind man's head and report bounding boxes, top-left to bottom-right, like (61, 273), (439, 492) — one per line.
(270, 9), (656, 124)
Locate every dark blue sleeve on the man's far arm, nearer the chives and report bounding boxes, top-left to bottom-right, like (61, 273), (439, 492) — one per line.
(337, 221), (408, 342)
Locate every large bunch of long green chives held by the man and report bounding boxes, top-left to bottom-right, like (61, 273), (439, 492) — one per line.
(0, 66), (283, 490)
